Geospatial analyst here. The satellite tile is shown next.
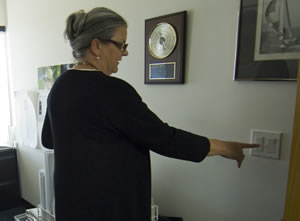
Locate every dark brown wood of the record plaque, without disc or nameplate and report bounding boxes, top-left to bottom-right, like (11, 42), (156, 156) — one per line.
(144, 11), (187, 84)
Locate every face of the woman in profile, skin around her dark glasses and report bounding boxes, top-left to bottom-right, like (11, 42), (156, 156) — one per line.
(100, 26), (128, 75)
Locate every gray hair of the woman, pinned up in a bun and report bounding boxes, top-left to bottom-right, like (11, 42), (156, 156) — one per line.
(64, 7), (127, 60)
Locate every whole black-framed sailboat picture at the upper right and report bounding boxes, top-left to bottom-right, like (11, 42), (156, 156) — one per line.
(234, 0), (300, 81)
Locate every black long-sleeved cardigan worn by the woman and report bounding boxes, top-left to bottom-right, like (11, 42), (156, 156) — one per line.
(42, 70), (209, 221)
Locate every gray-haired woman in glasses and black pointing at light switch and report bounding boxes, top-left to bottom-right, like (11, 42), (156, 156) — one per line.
(42, 8), (257, 221)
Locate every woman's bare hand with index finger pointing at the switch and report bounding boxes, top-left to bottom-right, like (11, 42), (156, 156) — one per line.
(208, 139), (259, 168)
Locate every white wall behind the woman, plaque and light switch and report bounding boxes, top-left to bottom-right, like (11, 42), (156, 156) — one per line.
(8, 0), (296, 221)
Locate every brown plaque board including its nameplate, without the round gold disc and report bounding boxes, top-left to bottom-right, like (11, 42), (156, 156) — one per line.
(144, 11), (187, 84)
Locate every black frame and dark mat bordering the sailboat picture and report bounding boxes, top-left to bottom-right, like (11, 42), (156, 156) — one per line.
(234, 0), (298, 81)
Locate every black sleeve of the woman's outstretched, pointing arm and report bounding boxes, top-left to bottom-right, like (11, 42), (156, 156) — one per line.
(98, 81), (210, 162)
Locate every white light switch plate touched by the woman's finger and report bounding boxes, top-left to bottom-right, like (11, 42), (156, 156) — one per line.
(250, 129), (281, 159)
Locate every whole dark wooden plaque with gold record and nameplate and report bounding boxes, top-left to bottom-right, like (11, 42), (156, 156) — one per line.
(145, 11), (187, 84)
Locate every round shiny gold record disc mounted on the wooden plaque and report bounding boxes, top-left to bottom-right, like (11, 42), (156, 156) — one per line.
(148, 23), (177, 59)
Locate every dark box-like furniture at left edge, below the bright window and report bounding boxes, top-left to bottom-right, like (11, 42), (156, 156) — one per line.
(0, 146), (21, 211)
